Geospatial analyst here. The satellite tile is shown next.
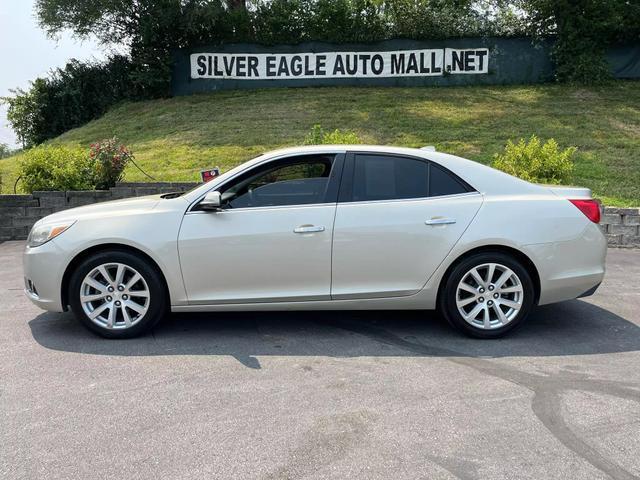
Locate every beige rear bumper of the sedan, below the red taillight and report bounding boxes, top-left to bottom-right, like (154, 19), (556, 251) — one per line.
(525, 223), (607, 305)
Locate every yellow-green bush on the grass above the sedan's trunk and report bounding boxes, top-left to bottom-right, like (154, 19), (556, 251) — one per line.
(492, 135), (577, 188)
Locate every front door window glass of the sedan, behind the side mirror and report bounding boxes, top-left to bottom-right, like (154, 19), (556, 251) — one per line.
(221, 155), (335, 208)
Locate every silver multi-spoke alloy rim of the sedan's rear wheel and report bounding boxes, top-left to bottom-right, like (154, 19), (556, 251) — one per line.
(456, 263), (524, 330)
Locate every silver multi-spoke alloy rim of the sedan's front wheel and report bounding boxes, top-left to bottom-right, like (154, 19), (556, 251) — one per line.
(80, 263), (150, 330)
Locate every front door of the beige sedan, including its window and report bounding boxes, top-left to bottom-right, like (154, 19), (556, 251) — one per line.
(178, 154), (344, 304)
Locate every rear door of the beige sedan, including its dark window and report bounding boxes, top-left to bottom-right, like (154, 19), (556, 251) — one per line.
(331, 153), (482, 299)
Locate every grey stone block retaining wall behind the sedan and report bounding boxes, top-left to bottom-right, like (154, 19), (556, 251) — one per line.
(0, 182), (640, 248)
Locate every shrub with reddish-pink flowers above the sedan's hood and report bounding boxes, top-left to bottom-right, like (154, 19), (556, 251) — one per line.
(89, 137), (133, 190)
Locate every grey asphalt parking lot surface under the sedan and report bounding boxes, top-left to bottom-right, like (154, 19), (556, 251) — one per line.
(0, 242), (640, 480)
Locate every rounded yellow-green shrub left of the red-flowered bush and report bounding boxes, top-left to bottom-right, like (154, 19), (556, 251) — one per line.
(19, 145), (93, 193)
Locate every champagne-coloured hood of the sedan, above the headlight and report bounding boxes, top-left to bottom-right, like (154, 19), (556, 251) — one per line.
(37, 195), (162, 224)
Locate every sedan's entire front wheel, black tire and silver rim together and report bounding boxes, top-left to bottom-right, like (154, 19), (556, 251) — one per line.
(68, 250), (167, 338)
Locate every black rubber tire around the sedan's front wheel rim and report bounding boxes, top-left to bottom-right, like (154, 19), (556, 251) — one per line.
(68, 250), (169, 339)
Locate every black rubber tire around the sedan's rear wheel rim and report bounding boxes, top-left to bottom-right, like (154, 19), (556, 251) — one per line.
(438, 252), (535, 339)
